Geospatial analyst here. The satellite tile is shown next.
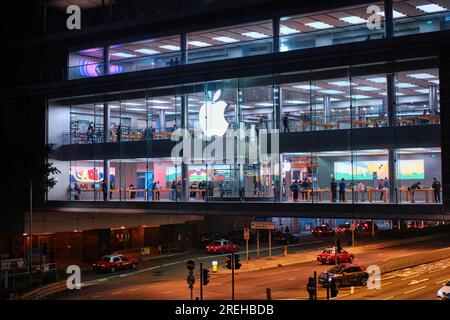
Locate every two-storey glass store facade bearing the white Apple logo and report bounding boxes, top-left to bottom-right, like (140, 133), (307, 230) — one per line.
(48, 62), (441, 204)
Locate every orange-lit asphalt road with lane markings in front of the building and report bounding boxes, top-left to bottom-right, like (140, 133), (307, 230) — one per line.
(52, 235), (450, 300)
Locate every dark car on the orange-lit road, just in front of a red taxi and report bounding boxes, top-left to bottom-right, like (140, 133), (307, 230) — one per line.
(318, 264), (369, 287)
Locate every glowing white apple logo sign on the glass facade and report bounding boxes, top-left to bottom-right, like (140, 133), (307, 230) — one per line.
(198, 90), (229, 138)
